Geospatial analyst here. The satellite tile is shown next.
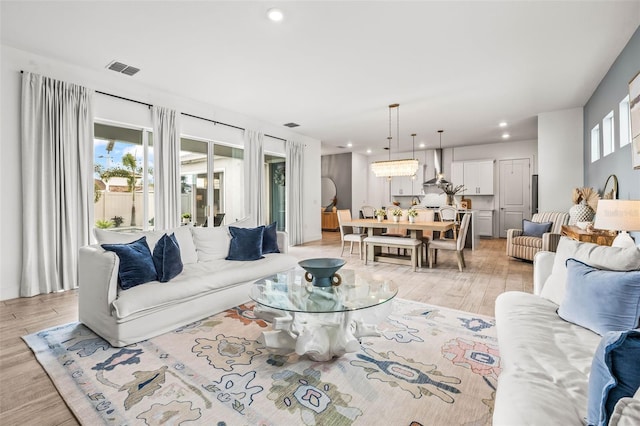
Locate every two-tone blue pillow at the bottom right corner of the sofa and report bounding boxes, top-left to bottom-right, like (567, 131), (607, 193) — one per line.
(587, 330), (640, 426)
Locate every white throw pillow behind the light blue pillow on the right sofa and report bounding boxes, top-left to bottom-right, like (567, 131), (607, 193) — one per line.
(540, 237), (640, 305)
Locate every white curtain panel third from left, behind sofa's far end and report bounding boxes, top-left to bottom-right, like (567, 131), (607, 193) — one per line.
(244, 130), (265, 226)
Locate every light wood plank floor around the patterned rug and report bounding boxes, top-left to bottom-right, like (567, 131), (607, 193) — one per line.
(0, 232), (533, 425)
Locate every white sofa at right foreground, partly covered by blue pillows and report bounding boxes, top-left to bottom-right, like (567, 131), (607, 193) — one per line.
(493, 237), (640, 426)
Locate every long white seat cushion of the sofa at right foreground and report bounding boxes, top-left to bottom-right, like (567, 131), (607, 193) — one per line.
(493, 292), (600, 426)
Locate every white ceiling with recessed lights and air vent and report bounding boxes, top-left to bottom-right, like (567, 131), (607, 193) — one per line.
(1, 0), (640, 154)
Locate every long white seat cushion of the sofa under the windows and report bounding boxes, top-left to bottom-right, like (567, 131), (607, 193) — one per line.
(112, 253), (298, 322)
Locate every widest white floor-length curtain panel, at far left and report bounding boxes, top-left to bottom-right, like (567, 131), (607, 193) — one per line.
(19, 72), (93, 297)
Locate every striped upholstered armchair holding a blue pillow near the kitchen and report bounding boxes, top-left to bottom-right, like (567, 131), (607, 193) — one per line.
(507, 212), (569, 260)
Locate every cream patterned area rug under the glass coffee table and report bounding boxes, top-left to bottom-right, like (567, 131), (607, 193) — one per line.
(24, 299), (500, 426)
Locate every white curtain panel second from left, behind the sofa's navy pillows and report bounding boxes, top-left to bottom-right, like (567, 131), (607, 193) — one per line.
(151, 106), (180, 229)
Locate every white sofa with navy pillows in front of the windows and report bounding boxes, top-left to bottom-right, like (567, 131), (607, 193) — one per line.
(79, 226), (297, 347)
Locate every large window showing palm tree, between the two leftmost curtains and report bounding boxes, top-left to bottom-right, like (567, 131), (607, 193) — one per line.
(94, 123), (154, 231)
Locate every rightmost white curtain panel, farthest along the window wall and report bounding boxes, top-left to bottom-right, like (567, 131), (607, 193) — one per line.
(285, 141), (304, 246)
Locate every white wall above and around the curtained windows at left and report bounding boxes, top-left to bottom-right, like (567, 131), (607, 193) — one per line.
(0, 45), (322, 300)
